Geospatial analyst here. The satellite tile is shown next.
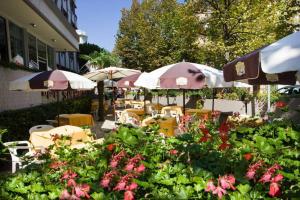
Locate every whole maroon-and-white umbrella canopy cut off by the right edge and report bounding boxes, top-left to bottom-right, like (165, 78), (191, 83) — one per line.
(223, 32), (300, 85)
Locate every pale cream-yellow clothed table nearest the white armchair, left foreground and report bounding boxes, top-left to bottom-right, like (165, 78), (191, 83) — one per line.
(29, 125), (93, 149)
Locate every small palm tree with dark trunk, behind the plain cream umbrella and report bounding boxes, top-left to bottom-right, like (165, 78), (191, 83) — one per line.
(81, 50), (120, 121)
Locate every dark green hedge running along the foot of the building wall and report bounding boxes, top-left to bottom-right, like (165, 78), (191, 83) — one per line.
(0, 97), (91, 141)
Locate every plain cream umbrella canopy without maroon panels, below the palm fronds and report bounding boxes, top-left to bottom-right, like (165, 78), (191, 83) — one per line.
(84, 67), (141, 81)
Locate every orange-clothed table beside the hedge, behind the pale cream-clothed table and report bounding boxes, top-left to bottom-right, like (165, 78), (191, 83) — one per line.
(56, 113), (94, 126)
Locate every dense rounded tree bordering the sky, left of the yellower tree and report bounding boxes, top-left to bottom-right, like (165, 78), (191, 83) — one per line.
(116, 0), (199, 71)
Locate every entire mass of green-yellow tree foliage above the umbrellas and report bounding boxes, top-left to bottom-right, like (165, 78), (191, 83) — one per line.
(115, 0), (300, 71)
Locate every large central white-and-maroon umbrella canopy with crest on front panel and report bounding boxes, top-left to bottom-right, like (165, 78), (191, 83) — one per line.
(134, 62), (248, 89)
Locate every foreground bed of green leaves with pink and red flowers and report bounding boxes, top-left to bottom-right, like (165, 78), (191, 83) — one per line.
(0, 117), (300, 200)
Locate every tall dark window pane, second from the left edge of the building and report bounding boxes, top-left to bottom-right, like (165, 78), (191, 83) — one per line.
(9, 22), (25, 64)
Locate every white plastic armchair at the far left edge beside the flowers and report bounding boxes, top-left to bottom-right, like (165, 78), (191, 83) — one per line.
(3, 141), (33, 173)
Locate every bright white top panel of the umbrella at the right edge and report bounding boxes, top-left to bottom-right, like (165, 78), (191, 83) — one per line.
(260, 31), (300, 73)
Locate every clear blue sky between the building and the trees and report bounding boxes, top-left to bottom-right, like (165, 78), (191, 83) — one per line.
(77, 0), (131, 51)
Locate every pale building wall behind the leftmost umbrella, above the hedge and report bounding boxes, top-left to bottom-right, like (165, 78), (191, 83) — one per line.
(0, 66), (48, 112)
